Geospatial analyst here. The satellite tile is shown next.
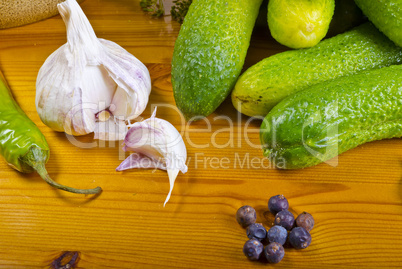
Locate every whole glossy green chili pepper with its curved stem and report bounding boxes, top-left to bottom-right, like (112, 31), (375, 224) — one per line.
(0, 71), (102, 194)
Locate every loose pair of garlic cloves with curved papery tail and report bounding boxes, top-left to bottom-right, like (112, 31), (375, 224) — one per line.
(116, 108), (187, 206)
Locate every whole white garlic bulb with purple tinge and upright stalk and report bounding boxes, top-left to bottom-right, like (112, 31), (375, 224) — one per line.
(35, 0), (151, 140)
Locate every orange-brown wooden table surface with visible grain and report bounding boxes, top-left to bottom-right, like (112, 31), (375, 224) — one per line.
(0, 0), (402, 268)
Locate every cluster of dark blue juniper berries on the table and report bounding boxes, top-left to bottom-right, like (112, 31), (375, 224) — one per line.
(236, 195), (314, 263)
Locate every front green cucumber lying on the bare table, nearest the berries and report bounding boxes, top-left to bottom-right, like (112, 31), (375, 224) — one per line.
(260, 65), (402, 169)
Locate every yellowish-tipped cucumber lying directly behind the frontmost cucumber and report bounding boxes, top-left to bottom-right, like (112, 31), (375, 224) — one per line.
(232, 22), (402, 117)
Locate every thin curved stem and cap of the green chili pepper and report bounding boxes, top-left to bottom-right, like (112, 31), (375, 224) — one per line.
(20, 147), (102, 194)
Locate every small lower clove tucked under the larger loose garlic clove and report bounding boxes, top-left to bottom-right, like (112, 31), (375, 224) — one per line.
(116, 153), (166, 171)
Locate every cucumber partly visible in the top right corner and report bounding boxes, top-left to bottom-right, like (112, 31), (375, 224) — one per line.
(355, 0), (402, 47)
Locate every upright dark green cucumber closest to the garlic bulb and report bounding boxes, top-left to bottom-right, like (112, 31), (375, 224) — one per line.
(172, 0), (262, 119)
